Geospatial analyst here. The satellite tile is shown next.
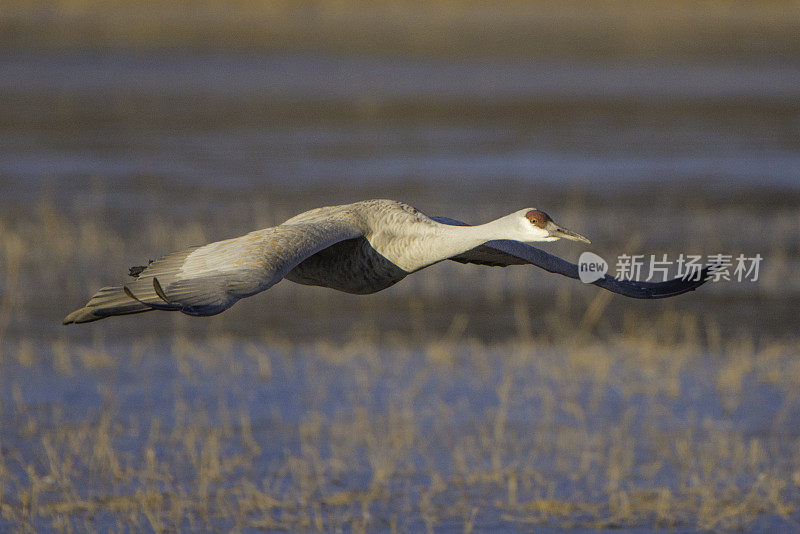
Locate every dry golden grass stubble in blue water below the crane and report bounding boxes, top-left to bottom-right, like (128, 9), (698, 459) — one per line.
(2, 332), (800, 530)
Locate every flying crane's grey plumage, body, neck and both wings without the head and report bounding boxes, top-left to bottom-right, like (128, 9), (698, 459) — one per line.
(64, 200), (707, 324)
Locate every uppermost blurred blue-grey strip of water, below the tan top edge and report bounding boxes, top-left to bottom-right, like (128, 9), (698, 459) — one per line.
(0, 52), (800, 101)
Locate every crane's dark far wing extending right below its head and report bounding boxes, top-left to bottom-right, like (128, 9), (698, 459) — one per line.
(431, 217), (713, 299)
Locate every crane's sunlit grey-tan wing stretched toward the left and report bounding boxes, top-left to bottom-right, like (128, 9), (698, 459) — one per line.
(64, 217), (362, 324)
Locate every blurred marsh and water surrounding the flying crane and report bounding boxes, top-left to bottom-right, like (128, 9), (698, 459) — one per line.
(0, 0), (800, 531)
